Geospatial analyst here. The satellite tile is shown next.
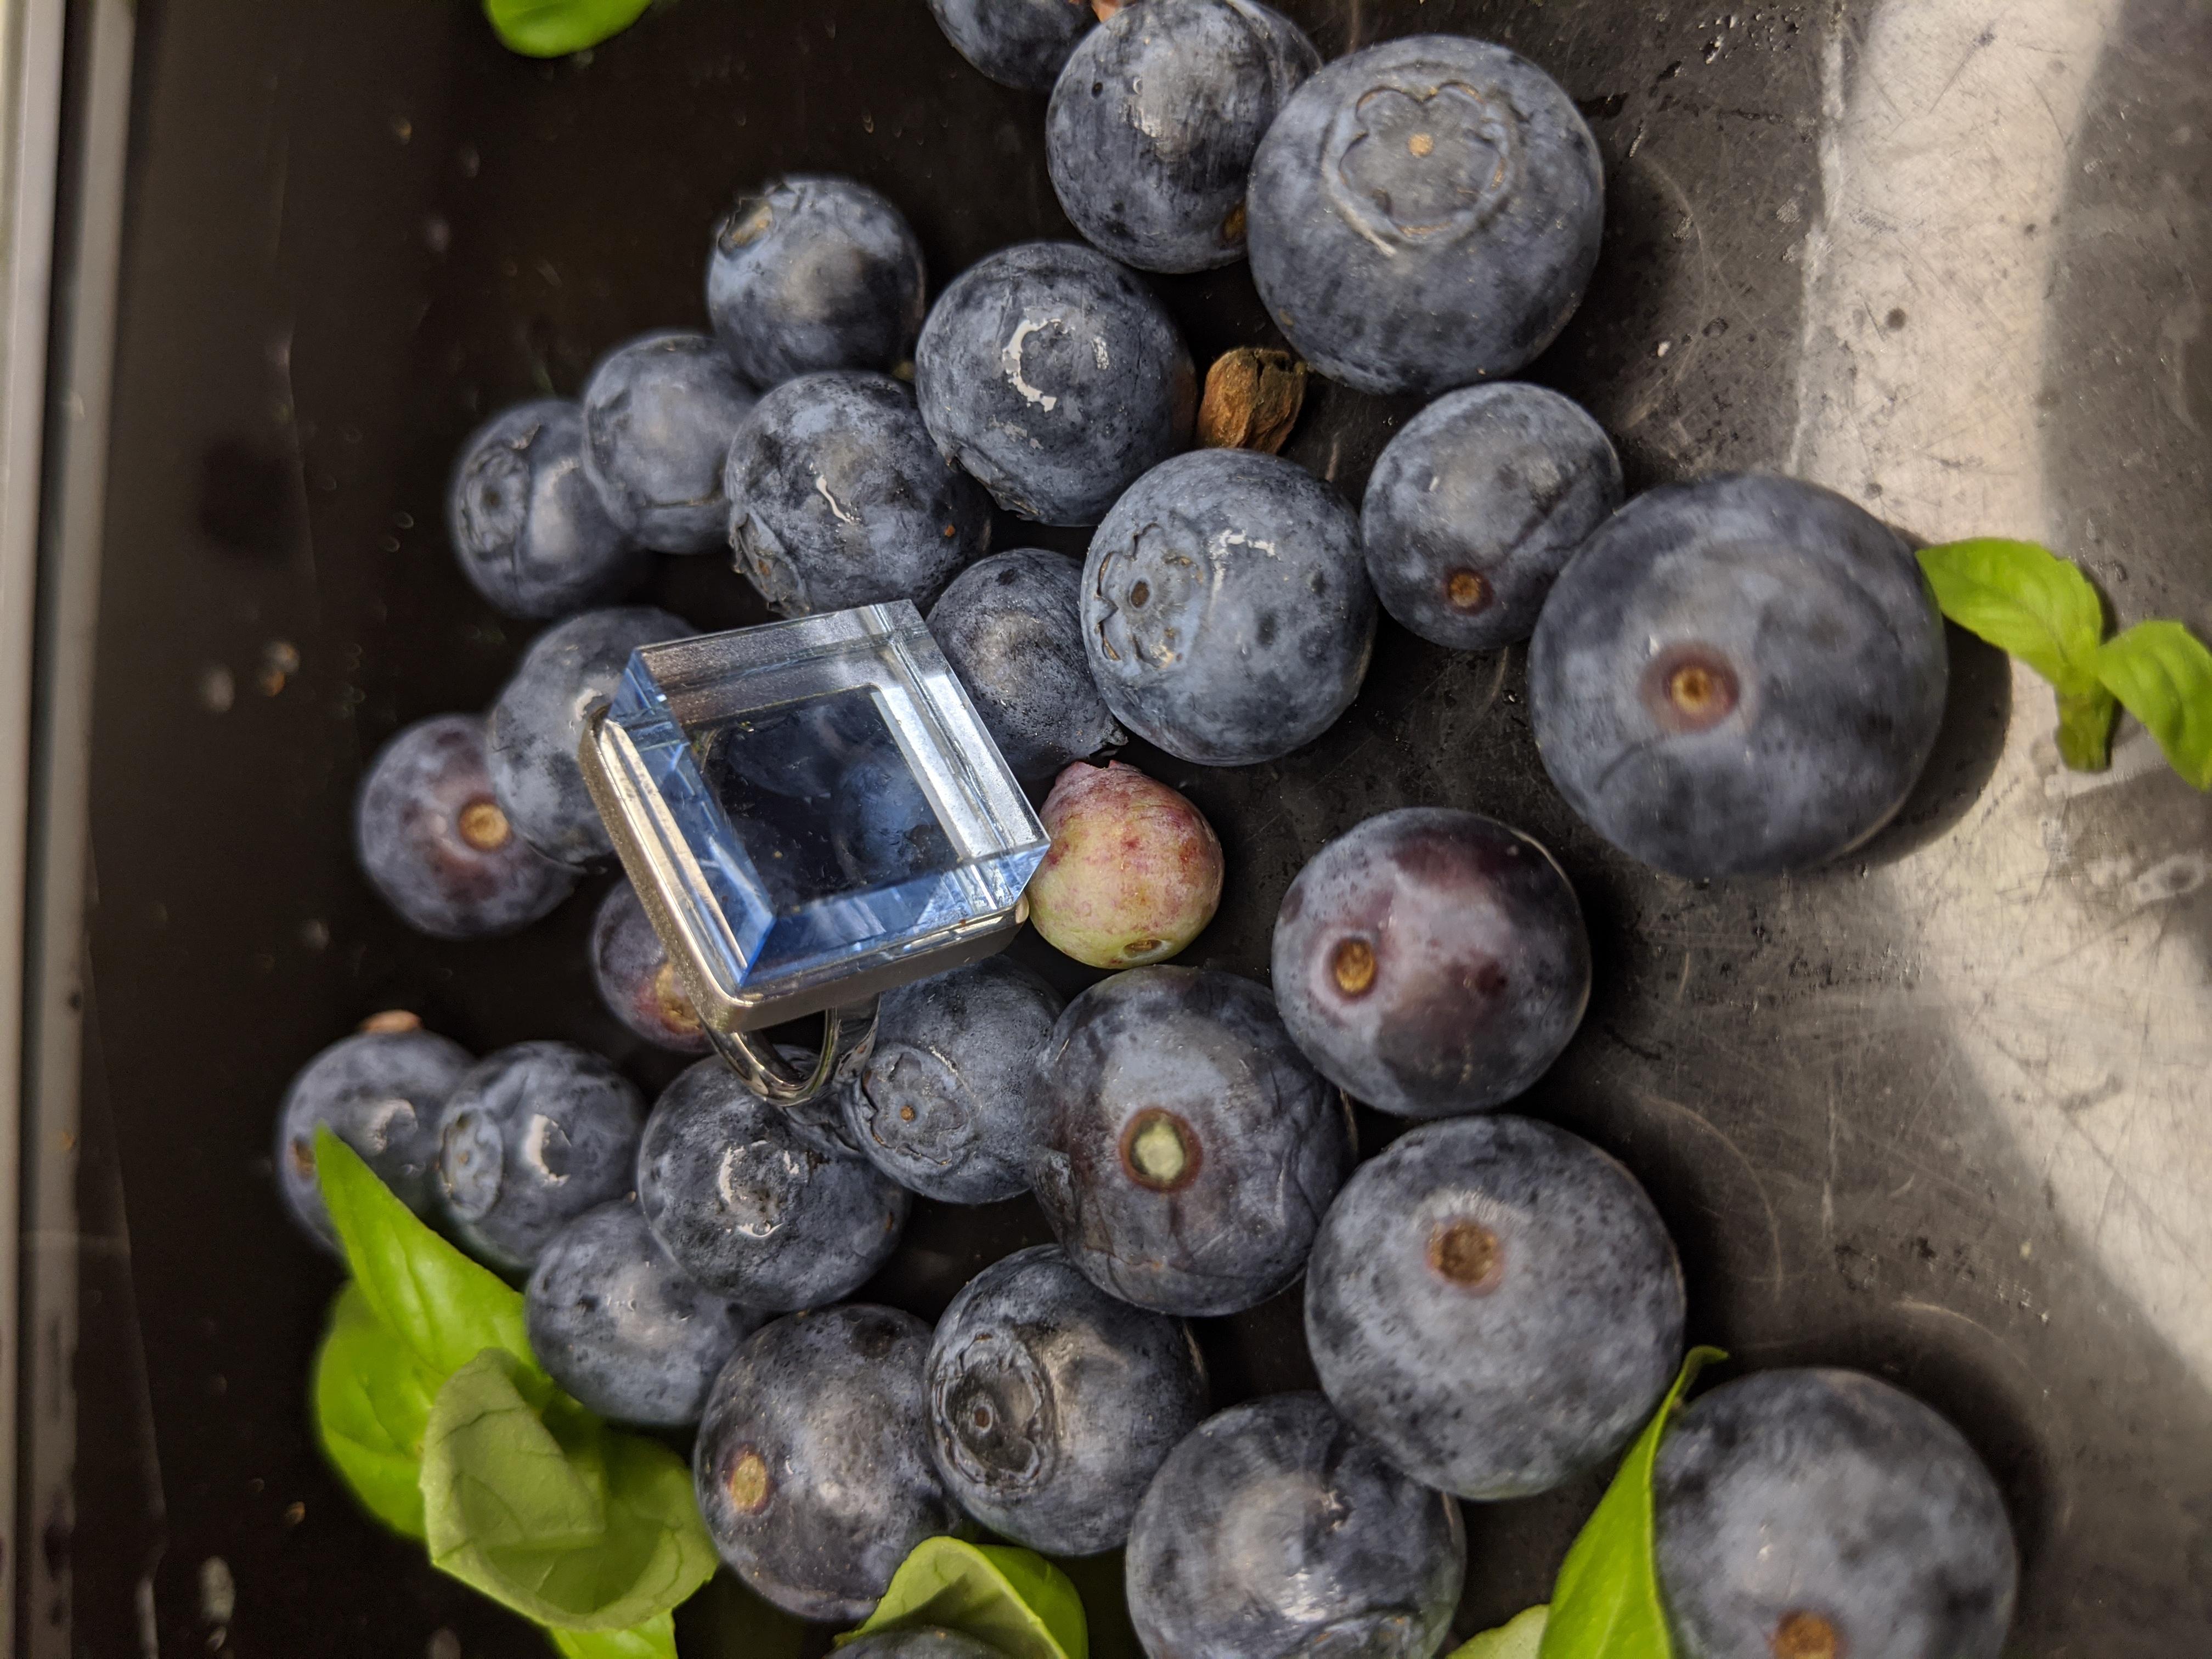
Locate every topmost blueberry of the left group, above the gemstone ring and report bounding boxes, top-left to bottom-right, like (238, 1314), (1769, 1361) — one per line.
(706, 172), (922, 387)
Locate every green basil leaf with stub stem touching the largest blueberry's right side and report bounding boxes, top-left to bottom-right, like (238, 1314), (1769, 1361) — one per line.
(1920, 538), (2115, 772)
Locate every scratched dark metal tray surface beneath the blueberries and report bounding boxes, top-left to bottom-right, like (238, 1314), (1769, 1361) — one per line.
(52, 0), (2212, 1659)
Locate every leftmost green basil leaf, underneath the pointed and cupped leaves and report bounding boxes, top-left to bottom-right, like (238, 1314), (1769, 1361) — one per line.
(312, 1285), (438, 1537)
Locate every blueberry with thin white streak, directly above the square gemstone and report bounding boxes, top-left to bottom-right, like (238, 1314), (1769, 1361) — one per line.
(723, 371), (991, 617)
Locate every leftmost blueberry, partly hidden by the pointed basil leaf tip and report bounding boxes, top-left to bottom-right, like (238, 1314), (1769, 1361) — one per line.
(276, 1031), (476, 1252)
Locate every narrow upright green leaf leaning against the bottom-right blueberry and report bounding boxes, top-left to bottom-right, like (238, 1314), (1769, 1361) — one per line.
(1537, 1347), (1728, 1659)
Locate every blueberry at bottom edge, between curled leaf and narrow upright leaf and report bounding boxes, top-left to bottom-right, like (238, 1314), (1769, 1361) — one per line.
(1126, 1393), (1466, 1659)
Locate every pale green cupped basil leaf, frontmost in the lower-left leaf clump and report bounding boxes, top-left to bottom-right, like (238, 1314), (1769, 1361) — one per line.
(422, 1347), (714, 1630)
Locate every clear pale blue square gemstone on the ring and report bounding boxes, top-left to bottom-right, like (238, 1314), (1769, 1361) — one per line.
(606, 600), (1048, 997)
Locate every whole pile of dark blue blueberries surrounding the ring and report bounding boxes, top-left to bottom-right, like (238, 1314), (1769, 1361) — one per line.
(307, 0), (2017, 1659)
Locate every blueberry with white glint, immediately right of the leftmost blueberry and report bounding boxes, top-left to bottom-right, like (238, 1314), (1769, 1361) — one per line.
(438, 1042), (646, 1274)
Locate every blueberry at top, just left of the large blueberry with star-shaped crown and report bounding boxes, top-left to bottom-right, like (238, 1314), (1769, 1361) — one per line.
(1044, 0), (1321, 270)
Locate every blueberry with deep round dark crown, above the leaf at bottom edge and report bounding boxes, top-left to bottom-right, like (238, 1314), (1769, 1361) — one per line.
(929, 1245), (1205, 1555)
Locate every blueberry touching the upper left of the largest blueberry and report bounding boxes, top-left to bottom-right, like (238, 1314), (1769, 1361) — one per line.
(1361, 381), (1621, 650)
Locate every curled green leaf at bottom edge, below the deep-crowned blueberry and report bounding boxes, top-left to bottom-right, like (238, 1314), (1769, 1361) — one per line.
(838, 1537), (1091, 1659)
